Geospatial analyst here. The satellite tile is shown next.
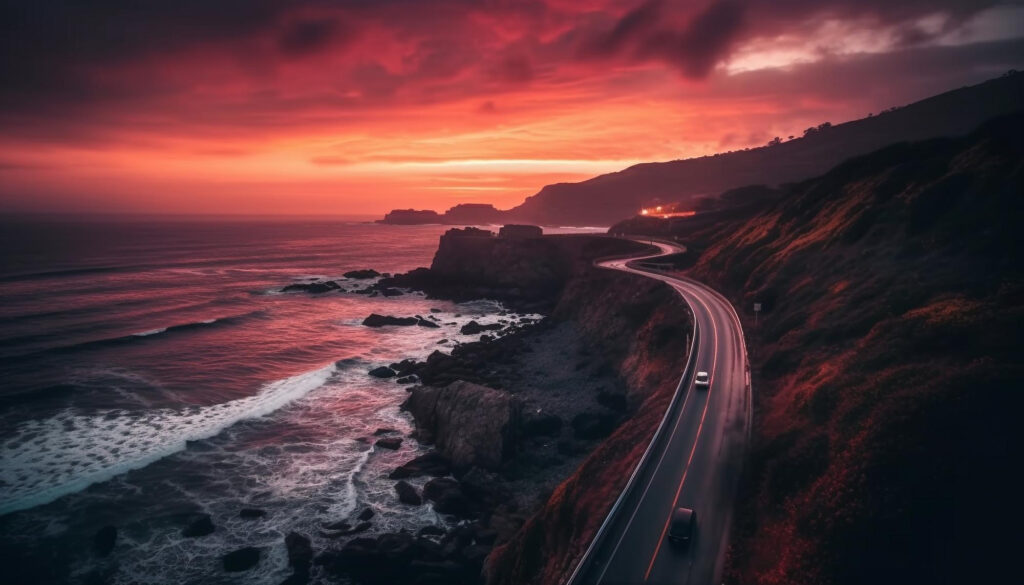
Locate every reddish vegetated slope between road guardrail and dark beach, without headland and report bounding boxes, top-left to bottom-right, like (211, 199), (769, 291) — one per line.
(486, 261), (692, 585)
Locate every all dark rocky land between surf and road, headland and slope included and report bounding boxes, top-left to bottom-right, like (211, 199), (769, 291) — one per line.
(297, 226), (691, 584)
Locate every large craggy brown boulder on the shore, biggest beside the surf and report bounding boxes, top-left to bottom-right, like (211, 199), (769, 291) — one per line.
(401, 380), (521, 469)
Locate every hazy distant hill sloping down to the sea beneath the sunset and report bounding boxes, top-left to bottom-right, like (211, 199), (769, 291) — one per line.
(507, 74), (1024, 225)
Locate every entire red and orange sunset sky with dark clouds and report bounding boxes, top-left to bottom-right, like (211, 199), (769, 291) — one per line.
(0, 0), (1024, 214)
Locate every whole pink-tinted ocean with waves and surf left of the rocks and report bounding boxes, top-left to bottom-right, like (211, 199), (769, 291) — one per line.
(0, 218), (598, 584)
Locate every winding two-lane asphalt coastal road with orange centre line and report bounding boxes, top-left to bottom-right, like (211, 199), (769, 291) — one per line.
(570, 242), (751, 585)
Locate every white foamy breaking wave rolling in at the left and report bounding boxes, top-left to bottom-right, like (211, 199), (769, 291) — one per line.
(0, 364), (337, 515)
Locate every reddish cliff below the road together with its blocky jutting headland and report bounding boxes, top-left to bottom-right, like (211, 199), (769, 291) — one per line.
(399, 231), (692, 584)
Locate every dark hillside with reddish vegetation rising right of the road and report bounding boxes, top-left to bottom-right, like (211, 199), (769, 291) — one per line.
(690, 114), (1024, 585)
